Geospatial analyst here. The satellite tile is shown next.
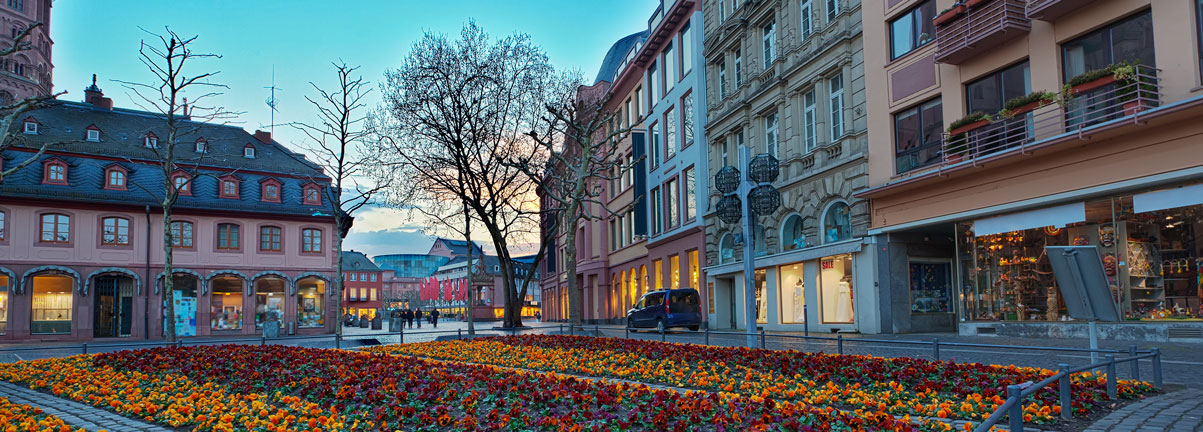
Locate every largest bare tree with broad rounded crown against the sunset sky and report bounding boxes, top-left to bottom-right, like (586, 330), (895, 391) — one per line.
(381, 22), (556, 326)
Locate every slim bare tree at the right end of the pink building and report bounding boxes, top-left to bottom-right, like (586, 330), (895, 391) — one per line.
(294, 63), (393, 335)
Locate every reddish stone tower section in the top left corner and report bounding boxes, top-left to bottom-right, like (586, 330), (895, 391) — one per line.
(0, 0), (54, 105)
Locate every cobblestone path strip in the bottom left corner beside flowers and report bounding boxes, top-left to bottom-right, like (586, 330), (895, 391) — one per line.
(0, 381), (171, 432)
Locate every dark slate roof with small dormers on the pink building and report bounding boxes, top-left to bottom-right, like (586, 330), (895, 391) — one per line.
(0, 101), (330, 215)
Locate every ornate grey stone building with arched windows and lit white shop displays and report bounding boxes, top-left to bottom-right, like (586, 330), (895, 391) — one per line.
(704, 0), (881, 333)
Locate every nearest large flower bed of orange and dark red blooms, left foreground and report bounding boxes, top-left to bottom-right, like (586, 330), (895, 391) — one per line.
(0, 345), (949, 431)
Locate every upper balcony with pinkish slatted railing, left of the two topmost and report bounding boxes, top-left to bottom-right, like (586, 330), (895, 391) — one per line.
(936, 0), (1032, 65)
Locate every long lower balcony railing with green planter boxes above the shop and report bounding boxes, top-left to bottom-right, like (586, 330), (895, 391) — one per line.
(941, 65), (1161, 166)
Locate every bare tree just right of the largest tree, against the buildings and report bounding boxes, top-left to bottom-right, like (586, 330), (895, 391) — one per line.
(515, 79), (640, 325)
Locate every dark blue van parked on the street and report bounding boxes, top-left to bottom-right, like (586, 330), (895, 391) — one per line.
(627, 288), (701, 331)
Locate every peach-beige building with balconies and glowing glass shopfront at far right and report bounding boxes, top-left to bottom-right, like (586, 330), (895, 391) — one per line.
(858, 0), (1203, 341)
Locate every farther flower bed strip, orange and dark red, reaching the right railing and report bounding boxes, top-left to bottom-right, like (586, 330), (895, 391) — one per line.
(369, 336), (1152, 424)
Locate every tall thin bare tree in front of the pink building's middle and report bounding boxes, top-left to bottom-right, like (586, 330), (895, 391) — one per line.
(118, 28), (235, 342)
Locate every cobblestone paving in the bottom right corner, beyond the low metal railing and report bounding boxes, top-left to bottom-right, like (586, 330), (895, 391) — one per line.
(1085, 389), (1203, 432)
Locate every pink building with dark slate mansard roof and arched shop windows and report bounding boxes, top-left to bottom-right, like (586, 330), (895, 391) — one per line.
(0, 85), (338, 341)
